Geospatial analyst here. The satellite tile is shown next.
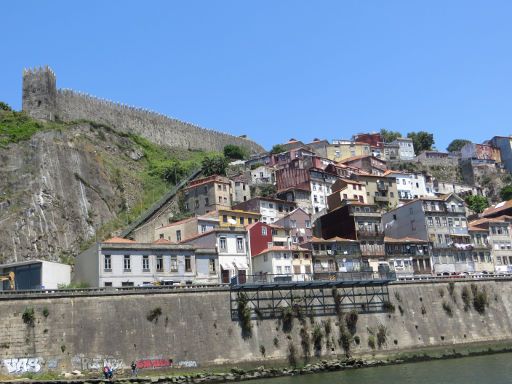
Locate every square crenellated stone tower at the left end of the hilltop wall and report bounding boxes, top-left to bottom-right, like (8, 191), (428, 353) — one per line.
(22, 66), (57, 121)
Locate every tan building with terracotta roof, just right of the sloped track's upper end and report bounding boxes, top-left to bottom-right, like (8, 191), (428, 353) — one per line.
(184, 175), (231, 215)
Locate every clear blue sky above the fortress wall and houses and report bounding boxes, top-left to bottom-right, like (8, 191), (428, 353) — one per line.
(0, 0), (512, 150)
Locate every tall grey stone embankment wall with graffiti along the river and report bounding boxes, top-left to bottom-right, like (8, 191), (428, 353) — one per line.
(0, 281), (512, 375)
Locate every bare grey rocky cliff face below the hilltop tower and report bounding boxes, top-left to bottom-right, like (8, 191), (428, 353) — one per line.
(0, 124), (166, 263)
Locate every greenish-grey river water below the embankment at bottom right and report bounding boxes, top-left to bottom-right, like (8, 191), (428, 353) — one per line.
(242, 353), (512, 384)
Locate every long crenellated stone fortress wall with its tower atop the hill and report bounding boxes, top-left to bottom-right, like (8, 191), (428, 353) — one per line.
(23, 67), (264, 153)
